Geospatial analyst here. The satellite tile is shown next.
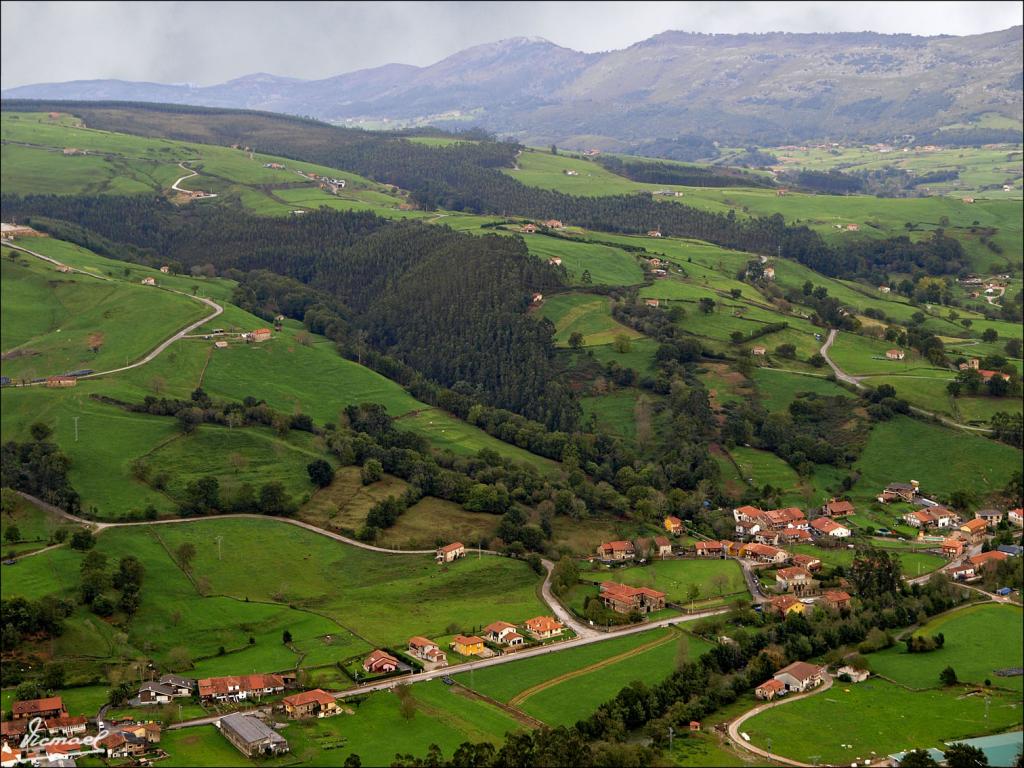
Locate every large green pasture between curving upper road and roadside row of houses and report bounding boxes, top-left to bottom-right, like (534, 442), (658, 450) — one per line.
(2, 519), (547, 679)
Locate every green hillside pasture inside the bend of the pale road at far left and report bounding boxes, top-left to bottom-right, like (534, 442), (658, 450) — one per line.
(0, 248), (210, 379)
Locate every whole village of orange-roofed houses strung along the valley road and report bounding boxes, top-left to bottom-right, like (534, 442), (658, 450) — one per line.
(2, 480), (1024, 768)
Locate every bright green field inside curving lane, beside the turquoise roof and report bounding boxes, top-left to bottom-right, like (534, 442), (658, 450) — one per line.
(743, 679), (1021, 765)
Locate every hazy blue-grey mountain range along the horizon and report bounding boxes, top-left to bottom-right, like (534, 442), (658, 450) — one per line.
(2, 27), (1024, 150)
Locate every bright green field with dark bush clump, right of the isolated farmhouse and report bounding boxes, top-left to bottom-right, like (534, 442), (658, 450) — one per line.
(870, 604), (1024, 691)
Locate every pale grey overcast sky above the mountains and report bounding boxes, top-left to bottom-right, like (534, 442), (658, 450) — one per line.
(0, 0), (1024, 88)
